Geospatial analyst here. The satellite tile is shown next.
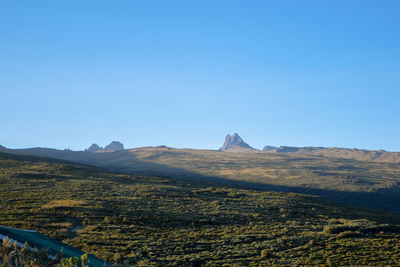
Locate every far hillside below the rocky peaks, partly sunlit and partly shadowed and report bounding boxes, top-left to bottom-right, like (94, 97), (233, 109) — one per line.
(8, 147), (400, 212)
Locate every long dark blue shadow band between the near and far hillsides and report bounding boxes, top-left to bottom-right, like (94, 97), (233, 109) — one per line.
(7, 148), (400, 216)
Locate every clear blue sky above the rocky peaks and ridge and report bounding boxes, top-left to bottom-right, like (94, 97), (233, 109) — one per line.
(0, 0), (400, 151)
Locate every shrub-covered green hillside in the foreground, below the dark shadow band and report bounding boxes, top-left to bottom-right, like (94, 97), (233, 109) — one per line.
(0, 153), (400, 266)
